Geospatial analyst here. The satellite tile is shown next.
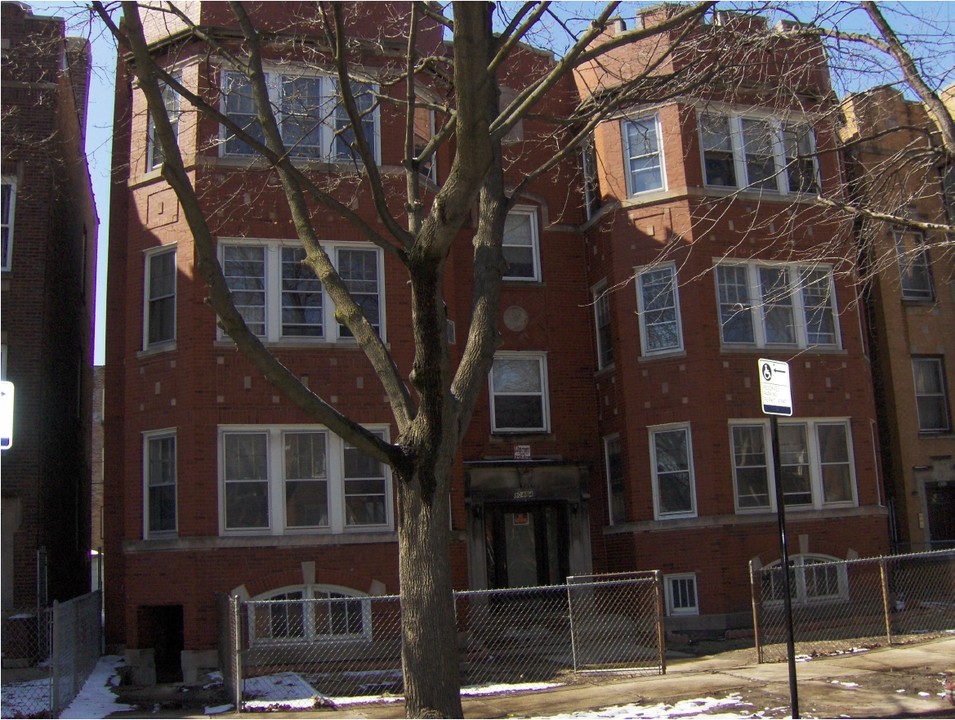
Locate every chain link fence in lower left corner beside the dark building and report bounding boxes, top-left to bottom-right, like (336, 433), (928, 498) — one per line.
(0, 592), (102, 717)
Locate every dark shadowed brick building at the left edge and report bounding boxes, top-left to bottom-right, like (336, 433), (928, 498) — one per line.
(0, 2), (98, 620)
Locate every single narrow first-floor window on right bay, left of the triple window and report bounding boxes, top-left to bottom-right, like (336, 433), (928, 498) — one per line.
(649, 424), (696, 520)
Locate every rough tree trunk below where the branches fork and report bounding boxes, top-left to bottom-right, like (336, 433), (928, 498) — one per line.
(398, 462), (463, 718)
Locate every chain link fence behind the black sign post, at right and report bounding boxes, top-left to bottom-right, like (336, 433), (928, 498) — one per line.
(750, 550), (955, 662)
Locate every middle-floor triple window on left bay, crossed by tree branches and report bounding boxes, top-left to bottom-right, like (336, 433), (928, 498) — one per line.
(219, 240), (385, 342)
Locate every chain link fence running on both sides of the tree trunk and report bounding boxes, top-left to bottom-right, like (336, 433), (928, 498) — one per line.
(219, 572), (665, 710)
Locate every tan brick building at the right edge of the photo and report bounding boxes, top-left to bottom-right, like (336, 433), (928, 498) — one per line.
(843, 86), (955, 551)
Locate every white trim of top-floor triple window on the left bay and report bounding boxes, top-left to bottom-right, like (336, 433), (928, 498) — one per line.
(218, 64), (381, 165)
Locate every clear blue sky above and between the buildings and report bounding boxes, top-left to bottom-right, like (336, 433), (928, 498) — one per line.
(29, 2), (955, 365)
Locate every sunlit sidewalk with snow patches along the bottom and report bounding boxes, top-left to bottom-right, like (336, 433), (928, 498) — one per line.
(111, 635), (955, 718)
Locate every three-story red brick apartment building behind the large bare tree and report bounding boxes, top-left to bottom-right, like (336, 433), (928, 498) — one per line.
(104, 3), (888, 678)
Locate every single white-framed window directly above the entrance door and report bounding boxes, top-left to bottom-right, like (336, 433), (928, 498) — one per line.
(489, 352), (550, 433)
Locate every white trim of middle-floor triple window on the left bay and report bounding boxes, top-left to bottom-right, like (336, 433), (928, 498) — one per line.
(216, 237), (388, 345)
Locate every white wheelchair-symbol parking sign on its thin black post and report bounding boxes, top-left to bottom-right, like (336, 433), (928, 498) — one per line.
(759, 359), (799, 719)
